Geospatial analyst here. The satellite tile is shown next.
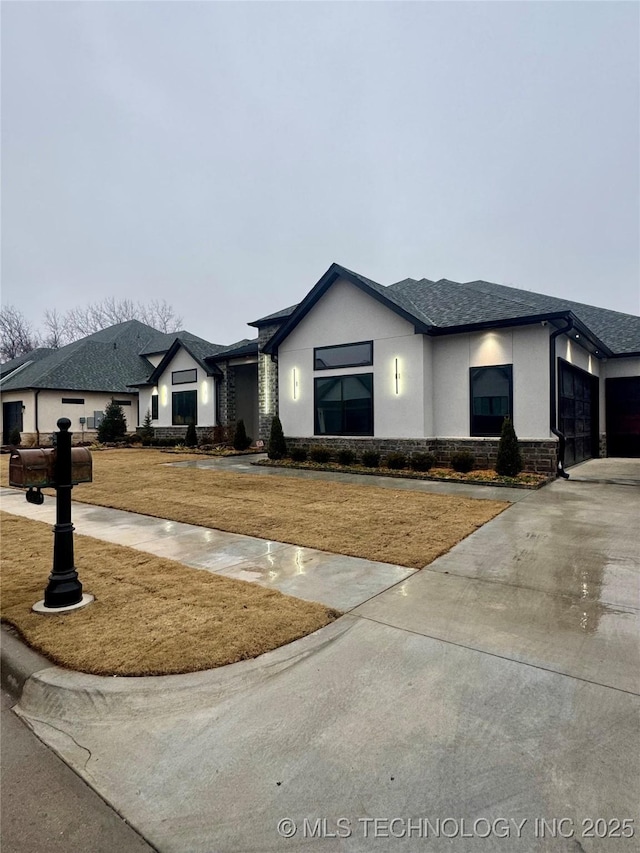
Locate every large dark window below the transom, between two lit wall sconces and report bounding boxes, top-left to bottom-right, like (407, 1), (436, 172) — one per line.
(315, 373), (373, 435)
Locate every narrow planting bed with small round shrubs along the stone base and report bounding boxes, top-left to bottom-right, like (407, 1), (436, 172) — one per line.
(251, 459), (555, 489)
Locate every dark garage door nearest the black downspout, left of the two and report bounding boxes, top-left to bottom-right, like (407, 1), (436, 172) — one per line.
(559, 360), (598, 467)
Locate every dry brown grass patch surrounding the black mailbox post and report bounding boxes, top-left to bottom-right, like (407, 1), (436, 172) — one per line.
(0, 512), (340, 675)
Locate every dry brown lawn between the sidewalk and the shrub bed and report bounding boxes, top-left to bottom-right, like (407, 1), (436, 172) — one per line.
(3, 449), (509, 568)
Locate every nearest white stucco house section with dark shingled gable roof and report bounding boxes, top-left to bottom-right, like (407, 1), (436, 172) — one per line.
(250, 264), (640, 472)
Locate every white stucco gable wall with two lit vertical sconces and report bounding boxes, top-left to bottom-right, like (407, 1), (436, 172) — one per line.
(278, 280), (422, 438)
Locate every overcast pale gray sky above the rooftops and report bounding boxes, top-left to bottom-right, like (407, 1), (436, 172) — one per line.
(2, 2), (640, 343)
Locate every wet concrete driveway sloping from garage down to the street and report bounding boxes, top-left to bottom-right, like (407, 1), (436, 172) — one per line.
(6, 472), (640, 853)
